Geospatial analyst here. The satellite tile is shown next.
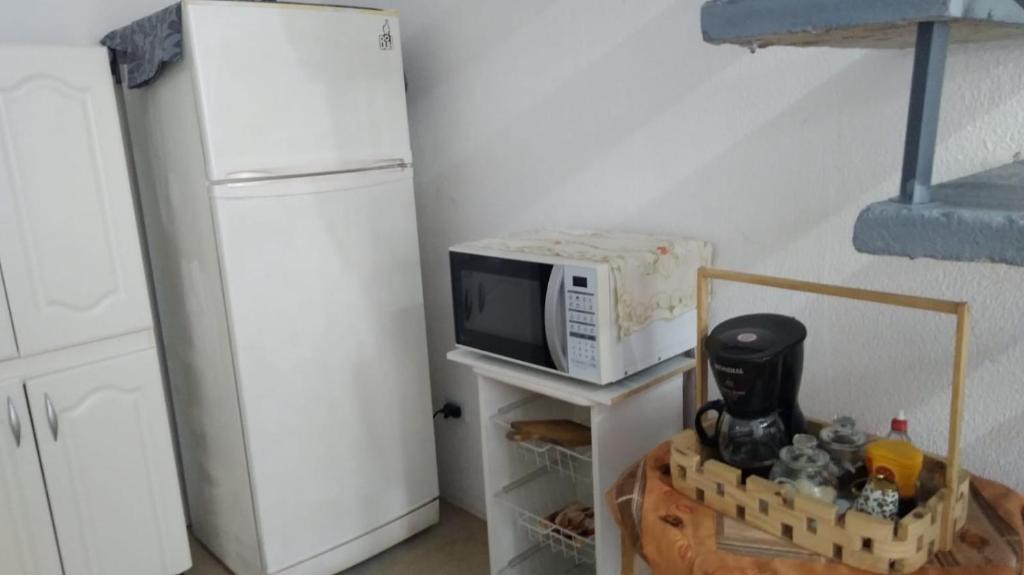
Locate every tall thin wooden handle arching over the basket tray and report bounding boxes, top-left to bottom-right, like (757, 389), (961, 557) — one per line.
(696, 267), (971, 550)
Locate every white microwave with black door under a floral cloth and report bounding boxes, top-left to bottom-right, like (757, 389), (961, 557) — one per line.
(449, 239), (696, 385)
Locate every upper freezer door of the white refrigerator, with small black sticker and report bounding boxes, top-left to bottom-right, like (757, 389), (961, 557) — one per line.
(183, 0), (412, 181)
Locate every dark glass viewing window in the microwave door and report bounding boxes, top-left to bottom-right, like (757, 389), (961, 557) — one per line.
(462, 270), (546, 346)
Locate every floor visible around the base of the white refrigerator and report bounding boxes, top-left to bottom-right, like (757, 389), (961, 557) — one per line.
(187, 503), (488, 575)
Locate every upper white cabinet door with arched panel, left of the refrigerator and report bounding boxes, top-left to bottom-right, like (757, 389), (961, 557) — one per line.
(0, 46), (151, 354)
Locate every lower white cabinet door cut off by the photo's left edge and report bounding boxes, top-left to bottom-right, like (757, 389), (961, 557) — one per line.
(0, 382), (60, 575)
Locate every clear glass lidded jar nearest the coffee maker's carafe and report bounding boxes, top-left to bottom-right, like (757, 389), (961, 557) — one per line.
(770, 434), (837, 503)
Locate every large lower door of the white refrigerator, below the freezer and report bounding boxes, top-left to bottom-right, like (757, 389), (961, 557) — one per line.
(212, 169), (437, 573)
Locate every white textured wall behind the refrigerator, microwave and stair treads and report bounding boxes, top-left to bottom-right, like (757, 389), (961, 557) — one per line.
(0, 0), (1024, 519)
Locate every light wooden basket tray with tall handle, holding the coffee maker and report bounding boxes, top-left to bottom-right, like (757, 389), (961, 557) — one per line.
(672, 267), (971, 573)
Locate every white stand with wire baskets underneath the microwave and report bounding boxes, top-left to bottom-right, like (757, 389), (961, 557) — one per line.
(447, 349), (695, 575)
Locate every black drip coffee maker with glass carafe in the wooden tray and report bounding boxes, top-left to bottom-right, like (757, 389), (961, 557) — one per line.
(696, 313), (807, 475)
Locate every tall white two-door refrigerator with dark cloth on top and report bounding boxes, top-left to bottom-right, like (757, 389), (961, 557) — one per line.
(124, 0), (438, 575)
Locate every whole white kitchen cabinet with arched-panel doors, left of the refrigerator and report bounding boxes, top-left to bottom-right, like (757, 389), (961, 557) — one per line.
(0, 46), (190, 575)
